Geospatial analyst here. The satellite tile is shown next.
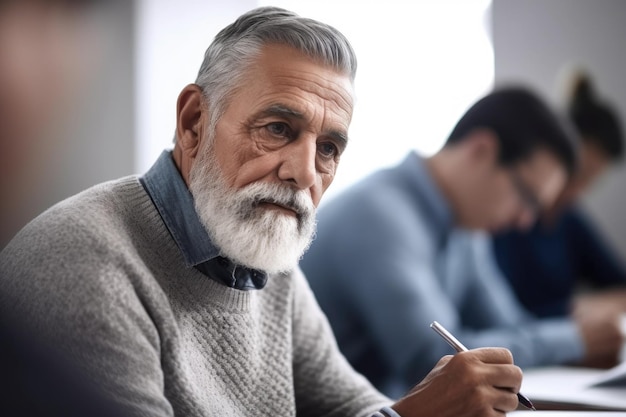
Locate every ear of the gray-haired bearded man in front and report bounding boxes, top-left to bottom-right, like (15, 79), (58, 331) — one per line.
(176, 84), (208, 159)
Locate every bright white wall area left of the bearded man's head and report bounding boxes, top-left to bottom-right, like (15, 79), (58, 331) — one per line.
(135, 0), (257, 173)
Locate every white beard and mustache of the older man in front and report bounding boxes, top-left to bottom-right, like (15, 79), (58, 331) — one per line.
(184, 138), (315, 274)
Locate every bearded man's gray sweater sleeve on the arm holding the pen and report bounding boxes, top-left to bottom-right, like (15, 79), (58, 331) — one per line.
(293, 269), (392, 417)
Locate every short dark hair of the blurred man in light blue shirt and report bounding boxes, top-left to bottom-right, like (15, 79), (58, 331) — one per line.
(445, 86), (577, 175)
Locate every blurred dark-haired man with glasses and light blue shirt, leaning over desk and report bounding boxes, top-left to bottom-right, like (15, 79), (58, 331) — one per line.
(300, 87), (622, 397)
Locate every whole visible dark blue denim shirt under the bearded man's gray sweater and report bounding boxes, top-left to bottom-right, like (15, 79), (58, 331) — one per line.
(139, 151), (267, 290)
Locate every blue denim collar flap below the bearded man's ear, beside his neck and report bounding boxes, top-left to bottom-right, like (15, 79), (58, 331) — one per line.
(140, 151), (219, 267)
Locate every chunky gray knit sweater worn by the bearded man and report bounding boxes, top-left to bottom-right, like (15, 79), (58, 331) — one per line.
(0, 177), (390, 417)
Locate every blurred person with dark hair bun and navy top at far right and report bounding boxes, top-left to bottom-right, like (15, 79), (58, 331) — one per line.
(493, 71), (626, 365)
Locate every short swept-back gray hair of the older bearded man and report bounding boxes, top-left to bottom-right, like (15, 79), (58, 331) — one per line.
(196, 7), (357, 136)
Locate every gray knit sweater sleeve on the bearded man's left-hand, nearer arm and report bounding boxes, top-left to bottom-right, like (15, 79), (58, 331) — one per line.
(0, 200), (173, 417)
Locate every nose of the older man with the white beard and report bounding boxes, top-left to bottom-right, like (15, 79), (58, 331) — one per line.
(278, 137), (317, 190)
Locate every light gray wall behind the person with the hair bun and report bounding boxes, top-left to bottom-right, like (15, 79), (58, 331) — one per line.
(492, 0), (626, 259)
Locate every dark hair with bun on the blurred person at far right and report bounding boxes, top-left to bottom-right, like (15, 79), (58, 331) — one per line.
(567, 73), (624, 160)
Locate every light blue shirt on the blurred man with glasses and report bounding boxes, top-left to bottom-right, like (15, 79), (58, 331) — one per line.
(300, 153), (583, 398)
